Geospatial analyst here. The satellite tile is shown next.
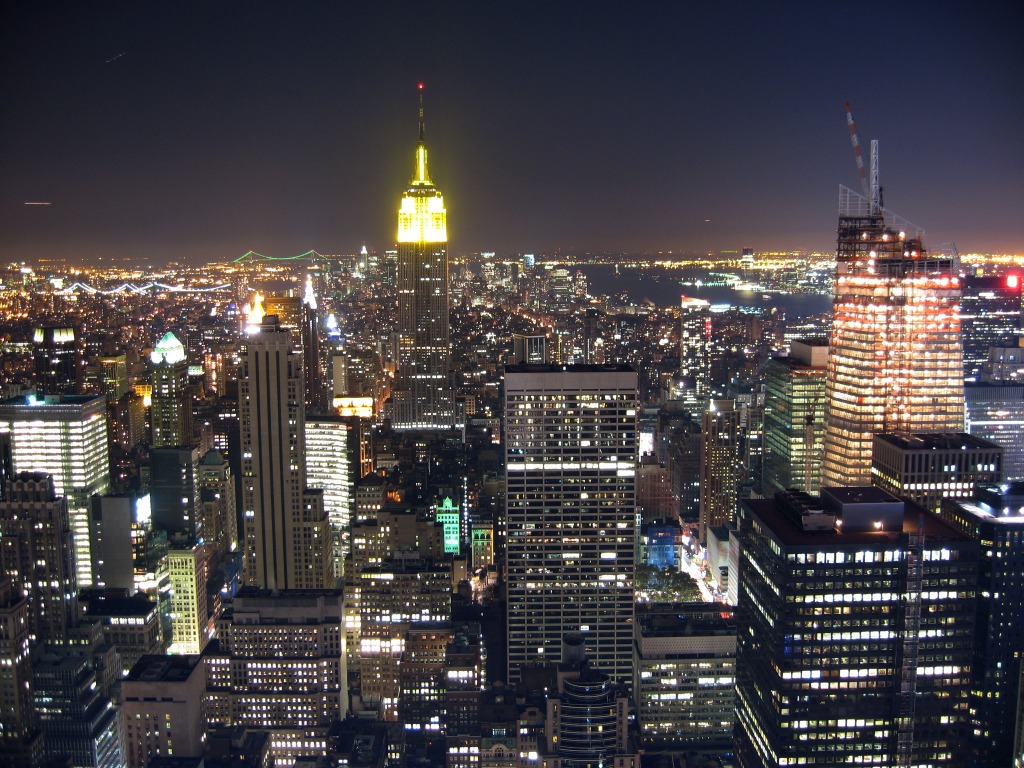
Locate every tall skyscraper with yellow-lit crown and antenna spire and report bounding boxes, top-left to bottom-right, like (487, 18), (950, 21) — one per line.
(392, 85), (455, 430)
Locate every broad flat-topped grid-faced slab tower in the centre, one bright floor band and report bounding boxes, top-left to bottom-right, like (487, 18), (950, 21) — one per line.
(505, 366), (637, 684)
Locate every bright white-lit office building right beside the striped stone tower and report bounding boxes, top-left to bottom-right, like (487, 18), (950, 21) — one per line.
(306, 416), (358, 579)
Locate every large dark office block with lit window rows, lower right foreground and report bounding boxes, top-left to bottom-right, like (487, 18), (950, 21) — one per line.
(735, 487), (978, 768)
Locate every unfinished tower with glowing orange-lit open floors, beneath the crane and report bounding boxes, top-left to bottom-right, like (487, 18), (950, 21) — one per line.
(821, 187), (964, 485)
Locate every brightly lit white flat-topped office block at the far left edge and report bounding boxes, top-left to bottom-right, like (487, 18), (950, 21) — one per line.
(0, 394), (110, 589)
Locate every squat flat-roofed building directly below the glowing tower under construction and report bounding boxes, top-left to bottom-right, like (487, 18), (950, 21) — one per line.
(871, 432), (1002, 513)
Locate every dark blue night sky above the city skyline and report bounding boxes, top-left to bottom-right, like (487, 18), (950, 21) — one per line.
(0, 0), (1024, 263)
